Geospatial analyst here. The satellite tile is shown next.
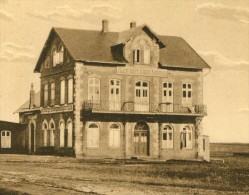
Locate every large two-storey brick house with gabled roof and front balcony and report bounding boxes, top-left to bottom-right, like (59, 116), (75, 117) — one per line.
(17, 20), (210, 160)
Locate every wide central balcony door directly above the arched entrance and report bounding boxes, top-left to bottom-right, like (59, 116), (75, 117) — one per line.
(135, 81), (149, 111)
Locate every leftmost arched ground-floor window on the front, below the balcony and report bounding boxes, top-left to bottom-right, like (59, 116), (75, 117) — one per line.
(87, 123), (99, 147)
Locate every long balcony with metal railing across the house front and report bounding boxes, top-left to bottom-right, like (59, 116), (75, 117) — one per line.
(83, 100), (207, 116)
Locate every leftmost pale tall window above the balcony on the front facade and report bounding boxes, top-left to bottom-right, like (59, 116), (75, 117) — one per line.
(88, 78), (100, 103)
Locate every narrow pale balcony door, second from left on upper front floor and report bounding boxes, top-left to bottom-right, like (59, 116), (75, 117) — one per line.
(109, 79), (121, 110)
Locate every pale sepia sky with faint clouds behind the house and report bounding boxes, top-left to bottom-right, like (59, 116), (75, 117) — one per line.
(0, 0), (249, 143)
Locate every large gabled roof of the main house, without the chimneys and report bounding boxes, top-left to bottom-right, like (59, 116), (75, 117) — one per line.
(34, 25), (210, 72)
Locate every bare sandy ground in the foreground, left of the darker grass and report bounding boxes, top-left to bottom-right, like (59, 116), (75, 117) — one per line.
(0, 154), (246, 195)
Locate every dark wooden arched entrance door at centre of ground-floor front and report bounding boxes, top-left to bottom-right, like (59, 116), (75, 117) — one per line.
(134, 122), (149, 156)
